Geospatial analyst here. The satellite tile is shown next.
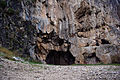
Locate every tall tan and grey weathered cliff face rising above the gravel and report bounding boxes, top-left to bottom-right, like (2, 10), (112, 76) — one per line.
(0, 0), (120, 64)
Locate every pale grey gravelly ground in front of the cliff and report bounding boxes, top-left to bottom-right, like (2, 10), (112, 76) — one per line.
(0, 58), (120, 80)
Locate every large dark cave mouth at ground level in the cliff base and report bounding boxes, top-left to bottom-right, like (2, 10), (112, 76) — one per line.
(46, 50), (75, 65)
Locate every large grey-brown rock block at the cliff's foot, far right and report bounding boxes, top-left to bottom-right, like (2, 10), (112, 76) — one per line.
(96, 45), (120, 63)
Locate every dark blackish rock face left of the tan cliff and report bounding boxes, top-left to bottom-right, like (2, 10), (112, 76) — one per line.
(0, 0), (37, 54)
